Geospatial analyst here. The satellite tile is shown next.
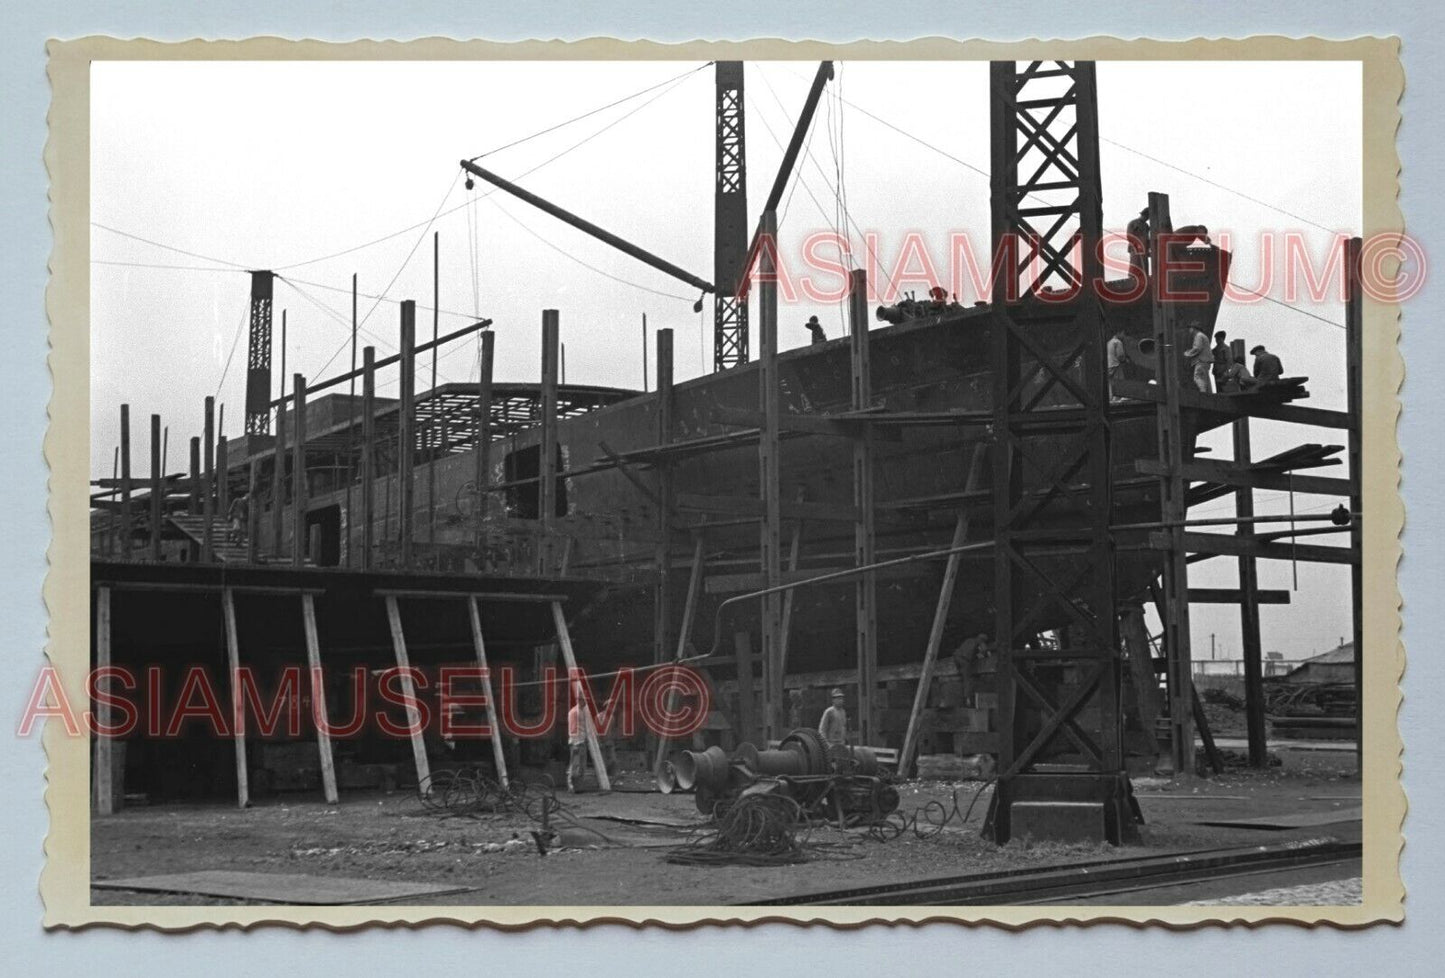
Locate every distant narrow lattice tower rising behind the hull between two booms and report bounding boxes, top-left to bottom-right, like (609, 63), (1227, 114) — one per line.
(712, 61), (749, 370)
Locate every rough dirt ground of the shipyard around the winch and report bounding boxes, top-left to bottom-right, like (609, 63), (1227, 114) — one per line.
(91, 750), (1360, 906)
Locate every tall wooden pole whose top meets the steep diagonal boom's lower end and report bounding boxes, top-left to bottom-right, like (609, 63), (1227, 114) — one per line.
(738, 211), (785, 741)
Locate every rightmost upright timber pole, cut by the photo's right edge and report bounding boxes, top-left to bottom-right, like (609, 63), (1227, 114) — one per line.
(1345, 238), (1364, 773)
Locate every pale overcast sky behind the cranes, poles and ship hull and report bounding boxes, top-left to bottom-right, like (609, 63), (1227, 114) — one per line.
(91, 62), (1361, 657)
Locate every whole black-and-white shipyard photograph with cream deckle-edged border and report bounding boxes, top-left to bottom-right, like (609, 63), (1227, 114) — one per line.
(42, 40), (1398, 926)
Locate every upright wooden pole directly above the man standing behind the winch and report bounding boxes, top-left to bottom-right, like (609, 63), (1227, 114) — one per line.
(848, 269), (879, 744)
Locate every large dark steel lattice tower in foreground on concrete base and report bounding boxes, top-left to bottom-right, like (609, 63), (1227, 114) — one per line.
(984, 61), (1137, 844)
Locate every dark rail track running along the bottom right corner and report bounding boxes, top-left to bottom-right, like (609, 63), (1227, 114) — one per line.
(749, 839), (1363, 907)
